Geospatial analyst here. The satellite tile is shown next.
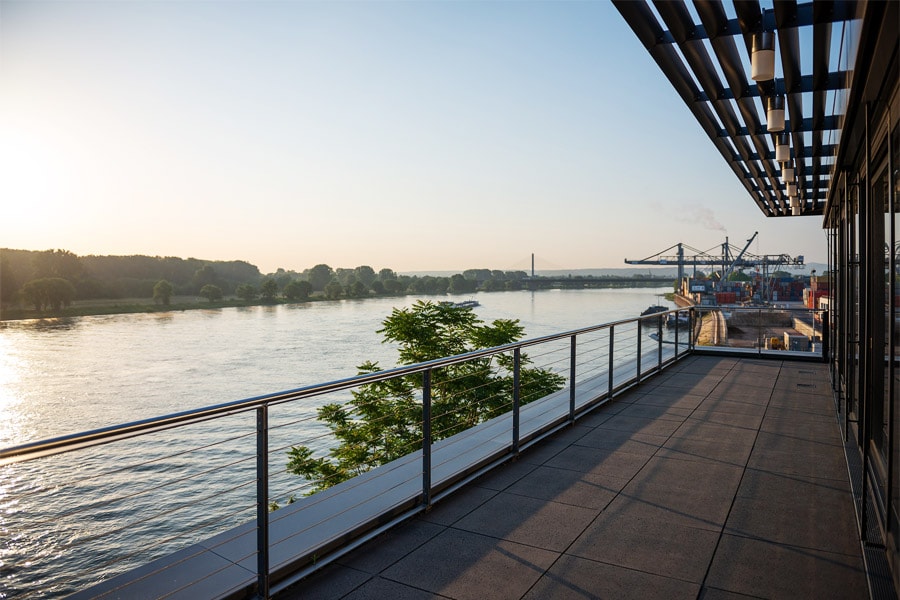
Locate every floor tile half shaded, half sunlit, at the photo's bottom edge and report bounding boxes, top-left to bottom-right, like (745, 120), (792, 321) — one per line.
(382, 529), (559, 600)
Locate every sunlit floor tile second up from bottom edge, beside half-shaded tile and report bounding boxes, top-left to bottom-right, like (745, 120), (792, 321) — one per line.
(566, 512), (719, 584)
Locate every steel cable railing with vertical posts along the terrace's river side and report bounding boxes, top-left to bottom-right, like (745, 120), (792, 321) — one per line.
(0, 309), (828, 597)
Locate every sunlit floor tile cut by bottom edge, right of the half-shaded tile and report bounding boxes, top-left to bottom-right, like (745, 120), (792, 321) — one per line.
(525, 555), (700, 600)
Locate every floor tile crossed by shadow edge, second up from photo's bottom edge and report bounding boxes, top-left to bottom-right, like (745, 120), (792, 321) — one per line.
(453, 492), (597, 552)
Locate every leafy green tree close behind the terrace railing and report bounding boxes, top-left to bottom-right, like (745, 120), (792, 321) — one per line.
(288, 301), (565, 490)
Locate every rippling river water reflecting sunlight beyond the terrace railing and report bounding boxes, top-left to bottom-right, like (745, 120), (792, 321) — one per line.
(0, 288), (669, 598)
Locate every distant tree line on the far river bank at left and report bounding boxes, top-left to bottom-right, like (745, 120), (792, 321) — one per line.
(0, 248), (527, 311)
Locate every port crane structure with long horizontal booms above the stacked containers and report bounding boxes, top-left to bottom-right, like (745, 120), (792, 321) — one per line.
(625, 232), (804, 300)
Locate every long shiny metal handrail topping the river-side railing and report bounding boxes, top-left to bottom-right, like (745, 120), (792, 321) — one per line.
(0, 307), (690, 466)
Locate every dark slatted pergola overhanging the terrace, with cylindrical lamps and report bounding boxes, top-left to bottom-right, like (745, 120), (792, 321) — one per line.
(615, 0), (859, 217)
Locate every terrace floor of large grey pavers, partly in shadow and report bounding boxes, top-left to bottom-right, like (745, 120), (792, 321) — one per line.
(282, 356), (868, 600)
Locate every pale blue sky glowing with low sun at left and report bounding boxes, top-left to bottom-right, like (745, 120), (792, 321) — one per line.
(0, 0), (826, 273)
